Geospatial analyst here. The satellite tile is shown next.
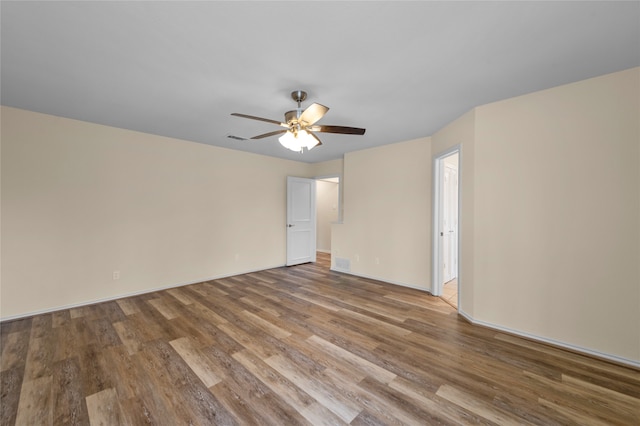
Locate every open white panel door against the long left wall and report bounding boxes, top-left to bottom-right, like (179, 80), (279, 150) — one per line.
(287, 176), (316, 266)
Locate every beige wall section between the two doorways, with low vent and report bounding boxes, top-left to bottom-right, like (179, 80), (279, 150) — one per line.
(331, 138), (431, 290)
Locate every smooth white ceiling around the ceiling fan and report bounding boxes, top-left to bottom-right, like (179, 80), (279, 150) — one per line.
(0, 1), (640, 163)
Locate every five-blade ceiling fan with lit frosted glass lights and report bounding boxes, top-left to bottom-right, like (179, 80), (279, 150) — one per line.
(231, 90), (365, 152)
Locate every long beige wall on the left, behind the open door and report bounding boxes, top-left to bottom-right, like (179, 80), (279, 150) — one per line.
(0, 107), (310, 318)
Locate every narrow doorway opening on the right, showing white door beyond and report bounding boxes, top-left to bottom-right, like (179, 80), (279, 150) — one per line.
(432, 146), (460, 309)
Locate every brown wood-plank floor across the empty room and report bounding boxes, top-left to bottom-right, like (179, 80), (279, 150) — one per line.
(0, 256), (640, 425)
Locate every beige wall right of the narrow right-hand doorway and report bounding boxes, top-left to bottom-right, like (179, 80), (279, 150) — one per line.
(472, 68), (640, 361)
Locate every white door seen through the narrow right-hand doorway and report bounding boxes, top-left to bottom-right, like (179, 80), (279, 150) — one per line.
(442, 164), (458, 283)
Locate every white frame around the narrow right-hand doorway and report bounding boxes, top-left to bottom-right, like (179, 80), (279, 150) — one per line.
(431, 144), (462, 302)
